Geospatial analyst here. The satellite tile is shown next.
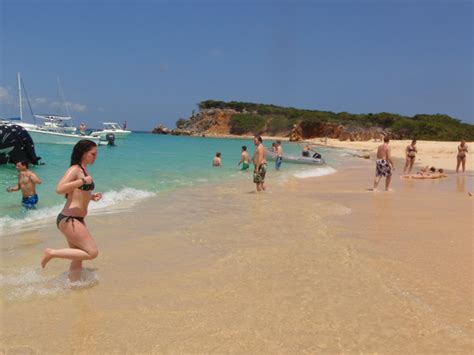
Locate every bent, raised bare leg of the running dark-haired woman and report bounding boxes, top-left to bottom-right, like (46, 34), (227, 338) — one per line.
(41, 220), (99, 268)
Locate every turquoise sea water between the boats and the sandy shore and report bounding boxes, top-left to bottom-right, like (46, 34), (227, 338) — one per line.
(0, 133), (340, 233)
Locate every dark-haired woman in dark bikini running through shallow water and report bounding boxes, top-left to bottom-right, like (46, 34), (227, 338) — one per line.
(41, 139), (102, 281)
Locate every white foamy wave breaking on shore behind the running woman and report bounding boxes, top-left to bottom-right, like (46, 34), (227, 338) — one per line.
(0, 187), (155, 235)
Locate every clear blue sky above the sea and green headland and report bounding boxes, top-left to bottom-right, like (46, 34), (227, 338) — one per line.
(0, 0), (474, 131)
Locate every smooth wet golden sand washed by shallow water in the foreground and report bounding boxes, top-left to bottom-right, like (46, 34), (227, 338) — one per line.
(0, 160), (474, 353)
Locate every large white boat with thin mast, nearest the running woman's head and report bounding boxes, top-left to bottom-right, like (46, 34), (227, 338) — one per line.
(11, 73), (100, 144)
